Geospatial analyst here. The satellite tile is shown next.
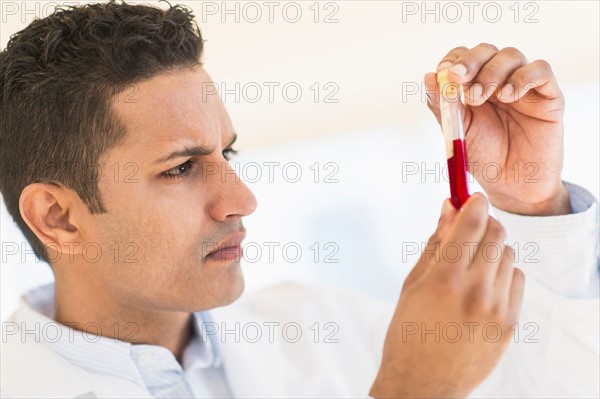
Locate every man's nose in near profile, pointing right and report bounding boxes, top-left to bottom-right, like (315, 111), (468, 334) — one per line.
(209, 162), (257, 222)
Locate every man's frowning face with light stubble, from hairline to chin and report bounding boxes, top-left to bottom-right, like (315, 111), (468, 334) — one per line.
(79, 67), (256, 311)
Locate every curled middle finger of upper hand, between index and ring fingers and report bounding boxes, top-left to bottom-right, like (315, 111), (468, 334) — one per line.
(465, 47), (527, 105)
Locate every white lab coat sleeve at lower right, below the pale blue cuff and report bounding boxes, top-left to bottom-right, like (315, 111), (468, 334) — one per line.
(470, 278), (600, 398)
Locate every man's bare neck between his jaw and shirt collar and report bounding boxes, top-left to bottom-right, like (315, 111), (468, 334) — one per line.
(54, 279), (193, 363)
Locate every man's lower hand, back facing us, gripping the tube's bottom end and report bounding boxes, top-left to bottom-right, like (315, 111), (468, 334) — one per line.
(369, 193), (525, 398)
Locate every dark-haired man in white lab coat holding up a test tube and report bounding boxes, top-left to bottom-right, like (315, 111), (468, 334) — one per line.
(0, 2), (598, 397)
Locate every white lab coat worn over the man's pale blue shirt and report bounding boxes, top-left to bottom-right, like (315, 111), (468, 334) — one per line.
(1, 280), (600, 398)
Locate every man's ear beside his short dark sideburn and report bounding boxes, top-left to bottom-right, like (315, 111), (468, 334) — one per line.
(19, 183), (82, 255)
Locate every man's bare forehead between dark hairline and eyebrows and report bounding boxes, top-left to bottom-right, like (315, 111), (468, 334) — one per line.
(112, 66), (233, 149)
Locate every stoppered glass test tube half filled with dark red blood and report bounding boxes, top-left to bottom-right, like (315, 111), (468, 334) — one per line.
(437, 70), (469, 209)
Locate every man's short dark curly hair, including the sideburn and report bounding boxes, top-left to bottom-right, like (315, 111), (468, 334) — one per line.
(0, 0), (203, 261)
